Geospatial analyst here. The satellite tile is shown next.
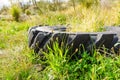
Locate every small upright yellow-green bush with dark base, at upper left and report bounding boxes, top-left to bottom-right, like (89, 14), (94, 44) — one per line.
(10, 5), (21, 21)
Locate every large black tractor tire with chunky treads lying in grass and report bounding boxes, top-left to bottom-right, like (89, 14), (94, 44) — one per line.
(28, 26), (120, 53)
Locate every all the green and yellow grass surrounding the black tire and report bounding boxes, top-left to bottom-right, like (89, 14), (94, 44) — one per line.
(0, 1), (120, 80)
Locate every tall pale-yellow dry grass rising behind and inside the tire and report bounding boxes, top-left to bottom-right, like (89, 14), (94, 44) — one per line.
(68, 5), (120, 32)
